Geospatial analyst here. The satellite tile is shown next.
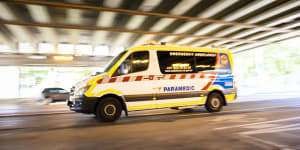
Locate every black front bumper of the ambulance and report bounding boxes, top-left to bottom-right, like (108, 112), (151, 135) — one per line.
(67, 95), (97, 114)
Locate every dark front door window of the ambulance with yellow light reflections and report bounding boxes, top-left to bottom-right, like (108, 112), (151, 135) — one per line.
(113, 51), (149, 76)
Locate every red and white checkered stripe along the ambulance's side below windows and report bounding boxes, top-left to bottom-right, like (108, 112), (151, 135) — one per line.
(97, 73), (217, 84)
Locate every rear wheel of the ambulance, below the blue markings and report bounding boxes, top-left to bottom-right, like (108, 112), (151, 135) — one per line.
(205, 92), (224, 112)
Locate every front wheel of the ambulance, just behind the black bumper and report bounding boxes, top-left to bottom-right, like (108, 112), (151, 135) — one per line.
(95, 97), (122, 122)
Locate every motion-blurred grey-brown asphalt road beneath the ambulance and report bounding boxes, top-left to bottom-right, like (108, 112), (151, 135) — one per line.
(0, 98), (300, 150)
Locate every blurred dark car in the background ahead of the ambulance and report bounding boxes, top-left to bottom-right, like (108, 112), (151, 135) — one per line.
(42, 88), (70, 103)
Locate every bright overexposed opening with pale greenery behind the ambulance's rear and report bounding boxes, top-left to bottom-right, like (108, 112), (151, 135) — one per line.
(233, 38), (300, 96)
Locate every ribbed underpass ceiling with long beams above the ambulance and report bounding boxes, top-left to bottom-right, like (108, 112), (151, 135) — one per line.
(0, 0), (300, 66)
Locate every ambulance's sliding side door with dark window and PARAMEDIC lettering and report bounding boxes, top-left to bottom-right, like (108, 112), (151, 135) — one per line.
(155, 51), (216, 107)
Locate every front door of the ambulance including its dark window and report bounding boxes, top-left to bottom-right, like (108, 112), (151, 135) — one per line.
(113, 51), (155, 111)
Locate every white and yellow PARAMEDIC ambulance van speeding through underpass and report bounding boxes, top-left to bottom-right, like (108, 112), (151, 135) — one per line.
(68, 43), (237, 122)
